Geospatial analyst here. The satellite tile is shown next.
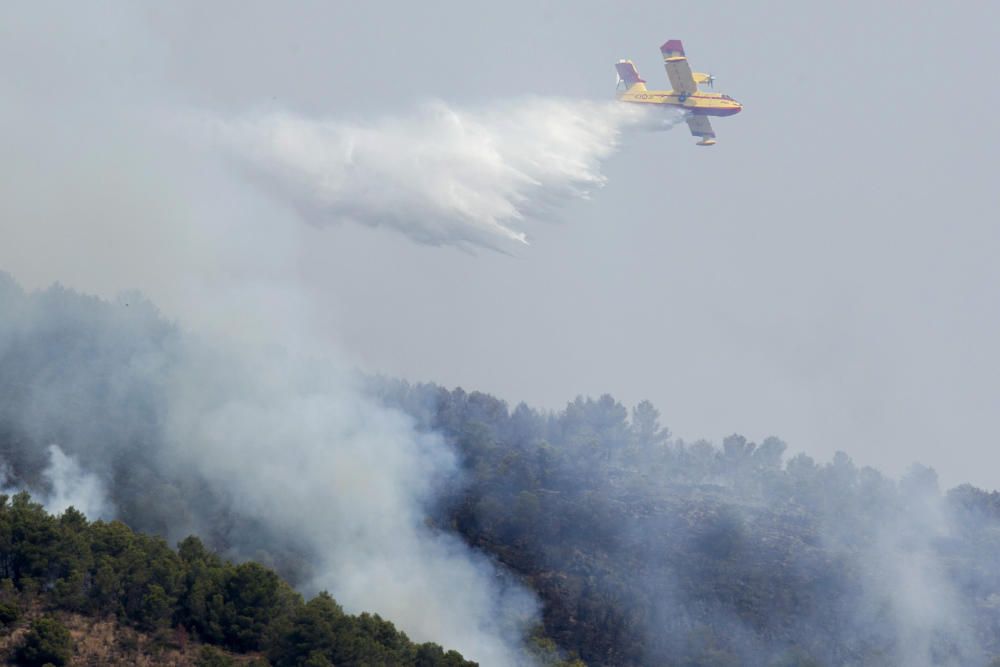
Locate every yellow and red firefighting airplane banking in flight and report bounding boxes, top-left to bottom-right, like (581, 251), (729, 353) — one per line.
(615, 39), (743, 146)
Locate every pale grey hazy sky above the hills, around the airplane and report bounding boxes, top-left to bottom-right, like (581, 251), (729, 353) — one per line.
(0, 0), (1000, 488)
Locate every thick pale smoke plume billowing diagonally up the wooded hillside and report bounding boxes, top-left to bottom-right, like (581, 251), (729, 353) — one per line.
(168, 344), (537, 665)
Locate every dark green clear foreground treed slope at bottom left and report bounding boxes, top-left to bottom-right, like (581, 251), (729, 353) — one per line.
(0, 493), (476, 667)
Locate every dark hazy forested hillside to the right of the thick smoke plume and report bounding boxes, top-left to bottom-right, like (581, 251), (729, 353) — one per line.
(376, 381), (1000, 666)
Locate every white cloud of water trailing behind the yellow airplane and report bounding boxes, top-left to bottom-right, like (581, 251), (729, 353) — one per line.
(213, 98), (684, 250)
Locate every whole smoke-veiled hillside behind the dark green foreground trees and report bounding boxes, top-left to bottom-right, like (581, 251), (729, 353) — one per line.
(0, 278), (1000, 665)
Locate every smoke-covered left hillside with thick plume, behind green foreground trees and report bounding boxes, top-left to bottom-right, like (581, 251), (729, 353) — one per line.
(0, 276), (536, 664)
